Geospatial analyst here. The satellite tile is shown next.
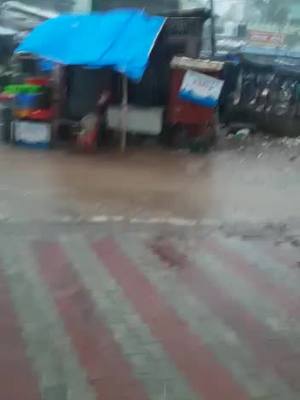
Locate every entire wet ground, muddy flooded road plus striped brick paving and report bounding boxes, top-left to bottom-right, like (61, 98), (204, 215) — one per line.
(0, 143), (300, 400)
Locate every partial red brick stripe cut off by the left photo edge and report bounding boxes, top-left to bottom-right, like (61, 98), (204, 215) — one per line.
(0, 268), (40, 400)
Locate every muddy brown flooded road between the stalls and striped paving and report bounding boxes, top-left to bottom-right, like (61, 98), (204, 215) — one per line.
(0, 143), (300, 222)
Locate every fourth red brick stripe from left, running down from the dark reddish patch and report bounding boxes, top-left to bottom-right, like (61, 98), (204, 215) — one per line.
(152, 242), (300, 390)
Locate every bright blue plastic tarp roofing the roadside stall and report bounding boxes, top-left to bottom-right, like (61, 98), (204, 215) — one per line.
(15, 9), (165, 80)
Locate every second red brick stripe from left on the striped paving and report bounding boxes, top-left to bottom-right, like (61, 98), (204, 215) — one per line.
(34, 242), (147, 400)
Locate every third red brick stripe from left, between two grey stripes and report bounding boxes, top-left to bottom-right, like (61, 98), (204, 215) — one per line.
(93, 239), (247, 400)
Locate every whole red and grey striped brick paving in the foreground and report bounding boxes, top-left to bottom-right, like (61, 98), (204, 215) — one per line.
(0, 233), (300, 400)
